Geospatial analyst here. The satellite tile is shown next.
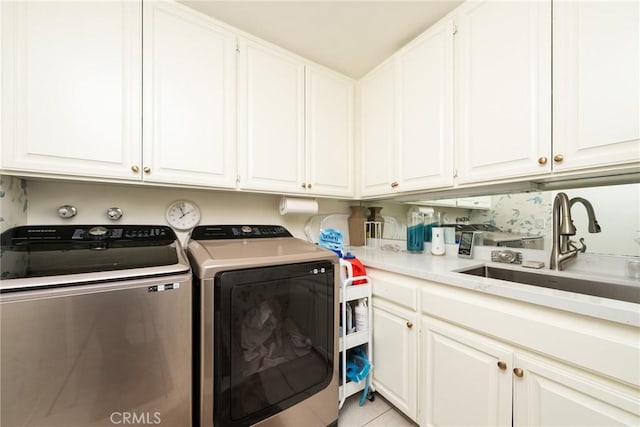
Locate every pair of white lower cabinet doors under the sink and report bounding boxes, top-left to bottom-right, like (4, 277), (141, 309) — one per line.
(421, 316), (640, 426)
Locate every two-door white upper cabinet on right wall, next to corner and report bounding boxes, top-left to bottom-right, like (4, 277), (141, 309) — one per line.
(360, 20), (453, 196)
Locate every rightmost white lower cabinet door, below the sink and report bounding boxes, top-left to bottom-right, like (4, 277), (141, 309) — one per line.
(513, 353), (640, 426)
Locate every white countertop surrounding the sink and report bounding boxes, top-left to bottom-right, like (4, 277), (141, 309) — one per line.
(347, 242), (640, 327)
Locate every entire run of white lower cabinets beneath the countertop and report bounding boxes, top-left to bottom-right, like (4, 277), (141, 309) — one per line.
(367, 266), (640, 426)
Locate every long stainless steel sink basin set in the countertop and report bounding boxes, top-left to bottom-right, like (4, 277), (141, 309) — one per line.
(458, 266), (640, 304)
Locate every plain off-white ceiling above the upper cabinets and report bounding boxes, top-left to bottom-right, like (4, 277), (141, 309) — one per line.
(181, 0), (462, 79)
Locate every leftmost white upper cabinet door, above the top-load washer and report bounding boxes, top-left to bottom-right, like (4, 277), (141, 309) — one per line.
(1, 1), (142, 180)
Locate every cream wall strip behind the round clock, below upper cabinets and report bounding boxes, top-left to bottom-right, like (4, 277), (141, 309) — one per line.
(27, 181), (353, 241)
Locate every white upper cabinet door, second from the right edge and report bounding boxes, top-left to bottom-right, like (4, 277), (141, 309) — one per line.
(456, 0), (551, 183)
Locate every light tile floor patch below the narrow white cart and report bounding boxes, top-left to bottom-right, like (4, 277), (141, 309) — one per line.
(338, 393), (416, 427)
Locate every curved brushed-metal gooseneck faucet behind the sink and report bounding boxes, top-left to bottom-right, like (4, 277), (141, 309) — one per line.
(549, 193), (601, 270)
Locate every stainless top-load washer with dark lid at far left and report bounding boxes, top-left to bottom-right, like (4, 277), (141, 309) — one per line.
(0, 225), (192, 427)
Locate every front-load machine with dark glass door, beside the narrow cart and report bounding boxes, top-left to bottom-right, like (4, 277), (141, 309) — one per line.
(187, 225), (339, 427)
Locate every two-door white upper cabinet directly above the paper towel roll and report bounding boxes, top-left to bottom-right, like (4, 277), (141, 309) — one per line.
(238, 40), (354, 197)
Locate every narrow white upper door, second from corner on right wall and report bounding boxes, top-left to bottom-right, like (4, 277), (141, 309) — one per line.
(396, 20), (453, 191)
